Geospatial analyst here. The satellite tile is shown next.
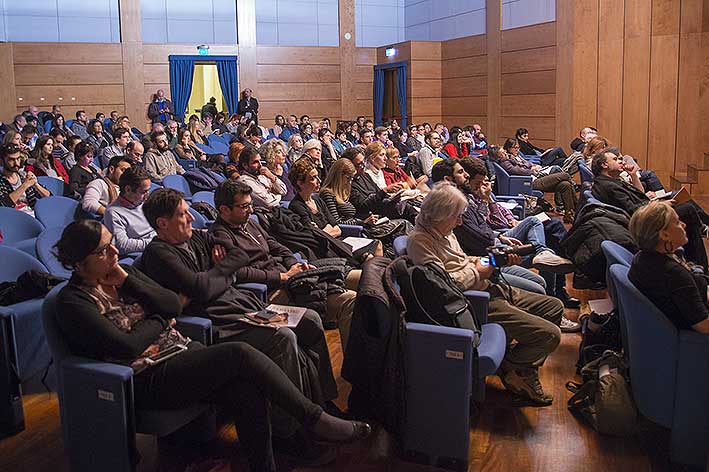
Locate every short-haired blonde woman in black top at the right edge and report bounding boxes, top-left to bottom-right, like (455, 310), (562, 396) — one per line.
(628, 201), (709, 334)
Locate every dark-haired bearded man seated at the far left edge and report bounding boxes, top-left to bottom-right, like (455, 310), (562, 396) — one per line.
(0, 144), (51, 216)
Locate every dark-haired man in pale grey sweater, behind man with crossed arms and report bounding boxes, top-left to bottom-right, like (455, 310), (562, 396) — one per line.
(103, 166), (155, 256)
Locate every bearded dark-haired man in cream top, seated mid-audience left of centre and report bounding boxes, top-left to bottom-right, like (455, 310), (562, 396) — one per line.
(237, 146), (288, 208)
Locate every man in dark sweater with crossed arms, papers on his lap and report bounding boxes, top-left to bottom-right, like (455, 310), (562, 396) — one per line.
(138, 189), (337, 460)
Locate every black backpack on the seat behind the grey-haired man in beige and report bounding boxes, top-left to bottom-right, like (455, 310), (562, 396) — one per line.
(395, 258), (480, 347)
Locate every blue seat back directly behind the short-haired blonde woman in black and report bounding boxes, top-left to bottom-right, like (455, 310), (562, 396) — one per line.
(610, 264), (679, 427)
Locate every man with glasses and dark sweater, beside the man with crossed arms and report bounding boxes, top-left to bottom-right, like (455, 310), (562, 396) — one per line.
(210, 180), (359, 352)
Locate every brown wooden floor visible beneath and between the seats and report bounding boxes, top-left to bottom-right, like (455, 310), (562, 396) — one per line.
(0, 300), (692, 472)
